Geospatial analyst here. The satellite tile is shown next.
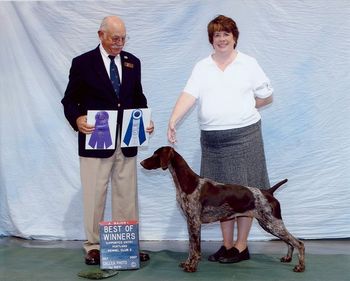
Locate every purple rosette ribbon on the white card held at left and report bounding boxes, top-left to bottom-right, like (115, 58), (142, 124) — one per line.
(89, 111), (112, 149)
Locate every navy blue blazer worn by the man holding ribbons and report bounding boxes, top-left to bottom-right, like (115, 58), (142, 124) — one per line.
(61, 46), (147, 158)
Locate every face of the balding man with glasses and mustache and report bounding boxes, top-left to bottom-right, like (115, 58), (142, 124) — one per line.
(98, 24), (126, 56)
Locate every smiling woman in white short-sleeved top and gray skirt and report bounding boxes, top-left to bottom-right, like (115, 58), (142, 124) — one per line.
(168, 15), (273, 263)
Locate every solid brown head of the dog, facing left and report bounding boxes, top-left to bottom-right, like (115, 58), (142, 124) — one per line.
(140, 146), (175, 170)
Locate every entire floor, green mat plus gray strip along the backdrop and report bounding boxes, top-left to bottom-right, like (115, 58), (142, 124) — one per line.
(0, 237), (350, 281)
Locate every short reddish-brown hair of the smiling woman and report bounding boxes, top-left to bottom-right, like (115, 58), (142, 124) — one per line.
(208, 15), (239, 48)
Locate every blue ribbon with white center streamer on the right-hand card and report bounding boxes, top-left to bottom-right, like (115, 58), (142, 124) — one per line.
(123, 109), (146, 145)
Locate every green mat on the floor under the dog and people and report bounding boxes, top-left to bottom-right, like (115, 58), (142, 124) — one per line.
(0, 245), (350, 281)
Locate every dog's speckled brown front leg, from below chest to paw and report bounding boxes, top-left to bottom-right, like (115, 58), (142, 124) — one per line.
(180, 218), (201, 272)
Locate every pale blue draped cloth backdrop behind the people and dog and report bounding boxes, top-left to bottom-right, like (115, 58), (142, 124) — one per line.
(0, 0), (350, 240)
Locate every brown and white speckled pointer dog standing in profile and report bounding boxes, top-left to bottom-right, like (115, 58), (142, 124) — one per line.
(141, 146), (305, 272)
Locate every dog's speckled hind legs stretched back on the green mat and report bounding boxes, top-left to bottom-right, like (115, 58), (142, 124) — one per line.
(258, 217), (305, 272)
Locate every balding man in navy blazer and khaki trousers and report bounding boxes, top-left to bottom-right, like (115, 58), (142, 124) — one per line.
(62, 16), (154, 265)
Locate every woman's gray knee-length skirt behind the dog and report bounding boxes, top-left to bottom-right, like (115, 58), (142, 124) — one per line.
(201, 121), (270, 189)
